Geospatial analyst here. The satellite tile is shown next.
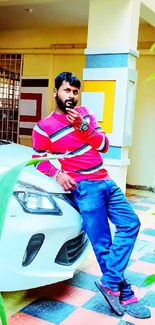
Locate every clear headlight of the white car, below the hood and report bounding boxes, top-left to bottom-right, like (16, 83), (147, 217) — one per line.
(13, 181), (62, 216)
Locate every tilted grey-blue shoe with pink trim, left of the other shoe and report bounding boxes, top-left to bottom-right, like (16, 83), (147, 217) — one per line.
(95, 280), (124, 316)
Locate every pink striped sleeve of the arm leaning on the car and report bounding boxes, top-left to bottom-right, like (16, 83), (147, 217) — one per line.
(32, 124), (58, 177)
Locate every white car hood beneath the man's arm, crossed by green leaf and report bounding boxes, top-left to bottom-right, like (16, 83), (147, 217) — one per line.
(0, 143), (64, 193)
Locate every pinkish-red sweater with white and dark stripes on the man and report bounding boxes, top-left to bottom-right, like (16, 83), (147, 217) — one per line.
(32, 106), (110, 182)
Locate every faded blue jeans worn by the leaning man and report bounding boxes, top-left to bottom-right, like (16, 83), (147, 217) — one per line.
(72, 180), (140, 300)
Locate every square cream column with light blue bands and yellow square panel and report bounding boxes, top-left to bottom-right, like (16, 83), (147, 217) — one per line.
(82, 0), (140, 192)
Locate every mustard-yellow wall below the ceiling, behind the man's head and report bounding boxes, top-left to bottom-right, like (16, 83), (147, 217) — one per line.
(0, 28), (87, 145)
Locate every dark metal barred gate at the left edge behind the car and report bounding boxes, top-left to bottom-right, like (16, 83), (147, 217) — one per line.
(0, 54), (22, 142)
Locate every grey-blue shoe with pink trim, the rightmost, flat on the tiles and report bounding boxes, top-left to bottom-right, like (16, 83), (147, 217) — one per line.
(120, 297), (151, 319)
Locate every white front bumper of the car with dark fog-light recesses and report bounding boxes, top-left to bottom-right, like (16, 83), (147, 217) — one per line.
(0, 197), (90, 291)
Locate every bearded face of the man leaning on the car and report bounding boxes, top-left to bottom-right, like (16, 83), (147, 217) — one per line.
(54, 81), (79, 113)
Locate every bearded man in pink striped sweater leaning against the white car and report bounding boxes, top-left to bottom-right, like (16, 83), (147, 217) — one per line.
(32, 72), (150, 318)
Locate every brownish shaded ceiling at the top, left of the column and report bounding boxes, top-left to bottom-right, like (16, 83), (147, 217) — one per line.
(0, 0), (146, 31)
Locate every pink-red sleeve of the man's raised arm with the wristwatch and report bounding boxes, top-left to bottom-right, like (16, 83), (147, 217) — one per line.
(77, 111), (109, 153)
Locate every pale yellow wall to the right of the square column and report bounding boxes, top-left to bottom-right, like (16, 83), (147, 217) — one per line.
(127, 55), (155, 187)
